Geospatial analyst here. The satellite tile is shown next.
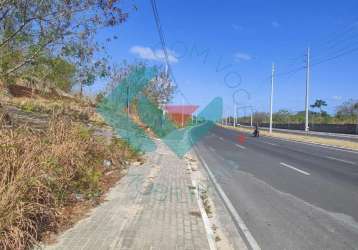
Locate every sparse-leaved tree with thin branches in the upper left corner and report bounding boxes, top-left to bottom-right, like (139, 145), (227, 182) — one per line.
(0, 0), (127, 94)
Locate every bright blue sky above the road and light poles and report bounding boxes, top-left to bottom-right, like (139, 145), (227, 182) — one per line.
(91, 0), (358, 114)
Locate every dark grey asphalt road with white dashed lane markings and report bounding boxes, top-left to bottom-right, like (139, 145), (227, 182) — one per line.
(196, 127), (358, 250)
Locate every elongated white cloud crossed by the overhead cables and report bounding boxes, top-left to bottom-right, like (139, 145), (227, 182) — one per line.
(129, 46), (178, 63)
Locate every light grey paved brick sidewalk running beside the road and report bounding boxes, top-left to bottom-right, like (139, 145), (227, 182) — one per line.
(43, 141), (209, 250)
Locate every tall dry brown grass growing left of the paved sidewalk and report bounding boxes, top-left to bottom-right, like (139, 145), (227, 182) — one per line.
(0, 119), (137, 249)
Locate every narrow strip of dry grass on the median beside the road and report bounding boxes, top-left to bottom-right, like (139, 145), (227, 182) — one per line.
(224, 126), (358, 150)
